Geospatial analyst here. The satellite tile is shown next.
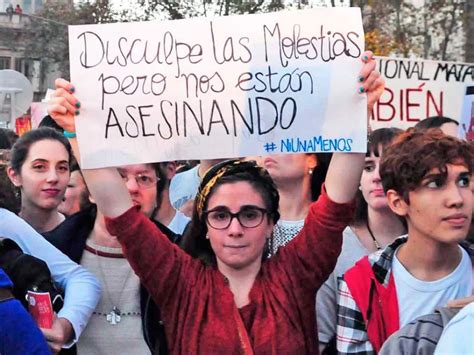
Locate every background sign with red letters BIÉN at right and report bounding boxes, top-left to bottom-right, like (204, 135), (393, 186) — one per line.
(371, 57), (474, 129)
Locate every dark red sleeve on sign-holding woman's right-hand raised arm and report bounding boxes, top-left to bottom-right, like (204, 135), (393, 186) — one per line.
(268, 186), (354, 292)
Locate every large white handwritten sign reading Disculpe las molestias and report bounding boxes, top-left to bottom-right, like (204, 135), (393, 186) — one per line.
(69, 8), (366, 168)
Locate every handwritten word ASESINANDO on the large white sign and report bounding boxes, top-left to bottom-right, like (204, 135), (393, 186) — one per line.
(104, 96), (298, 140)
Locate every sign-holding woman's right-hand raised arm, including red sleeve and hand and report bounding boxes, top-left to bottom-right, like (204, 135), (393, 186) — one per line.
(266, 52), (384, 294)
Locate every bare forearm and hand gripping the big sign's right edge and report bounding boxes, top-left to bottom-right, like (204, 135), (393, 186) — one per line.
(326, 52), (385, 203)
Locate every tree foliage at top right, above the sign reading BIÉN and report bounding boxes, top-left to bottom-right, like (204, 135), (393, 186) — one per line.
(352, 0), (464, 60)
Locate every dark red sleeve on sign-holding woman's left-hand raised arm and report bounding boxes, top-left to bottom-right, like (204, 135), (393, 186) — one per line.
(106, 207), (201, 306)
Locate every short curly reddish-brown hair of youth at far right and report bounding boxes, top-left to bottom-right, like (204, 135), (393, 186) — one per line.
(380, 128), (474, 203)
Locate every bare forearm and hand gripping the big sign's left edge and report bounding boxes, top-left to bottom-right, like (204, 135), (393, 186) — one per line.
(48, 79), (132, 218)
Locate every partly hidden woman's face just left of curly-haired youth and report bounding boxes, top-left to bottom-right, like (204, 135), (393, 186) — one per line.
(360, 149), (388, 210)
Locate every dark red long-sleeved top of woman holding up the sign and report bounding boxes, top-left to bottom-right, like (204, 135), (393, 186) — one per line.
(107, 192), (353, 354)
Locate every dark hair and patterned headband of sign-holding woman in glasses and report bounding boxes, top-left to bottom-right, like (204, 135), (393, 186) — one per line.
(180, 160), (280, 265)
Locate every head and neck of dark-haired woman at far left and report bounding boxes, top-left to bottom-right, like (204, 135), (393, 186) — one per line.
(7, 128), (71, 233)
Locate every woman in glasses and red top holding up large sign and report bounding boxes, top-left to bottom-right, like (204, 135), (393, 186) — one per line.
(48, 52), (384, 354)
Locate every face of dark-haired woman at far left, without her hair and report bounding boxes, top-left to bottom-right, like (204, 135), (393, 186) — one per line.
(9, 139), (70, 209)
